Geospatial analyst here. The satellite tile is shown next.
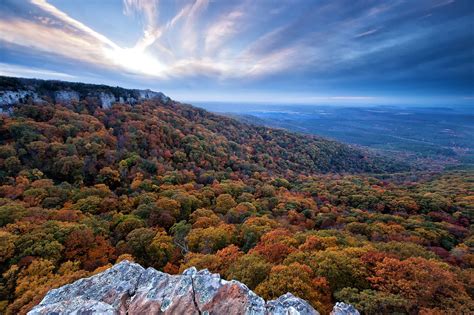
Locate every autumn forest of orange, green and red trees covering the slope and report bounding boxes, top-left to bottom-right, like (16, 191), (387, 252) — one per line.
(0, 84), (474, 314)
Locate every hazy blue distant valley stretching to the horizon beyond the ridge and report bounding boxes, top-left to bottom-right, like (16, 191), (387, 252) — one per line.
(197, 103), (474, 167)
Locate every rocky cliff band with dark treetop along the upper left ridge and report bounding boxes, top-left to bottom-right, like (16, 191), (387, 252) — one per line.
(0, 76), (169, 109)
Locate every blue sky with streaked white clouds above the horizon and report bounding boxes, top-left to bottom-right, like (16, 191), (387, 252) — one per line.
(0, 0), (474, 105)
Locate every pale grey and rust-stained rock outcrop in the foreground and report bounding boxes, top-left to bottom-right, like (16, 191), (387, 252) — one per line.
(29, 261), (358, 315)
